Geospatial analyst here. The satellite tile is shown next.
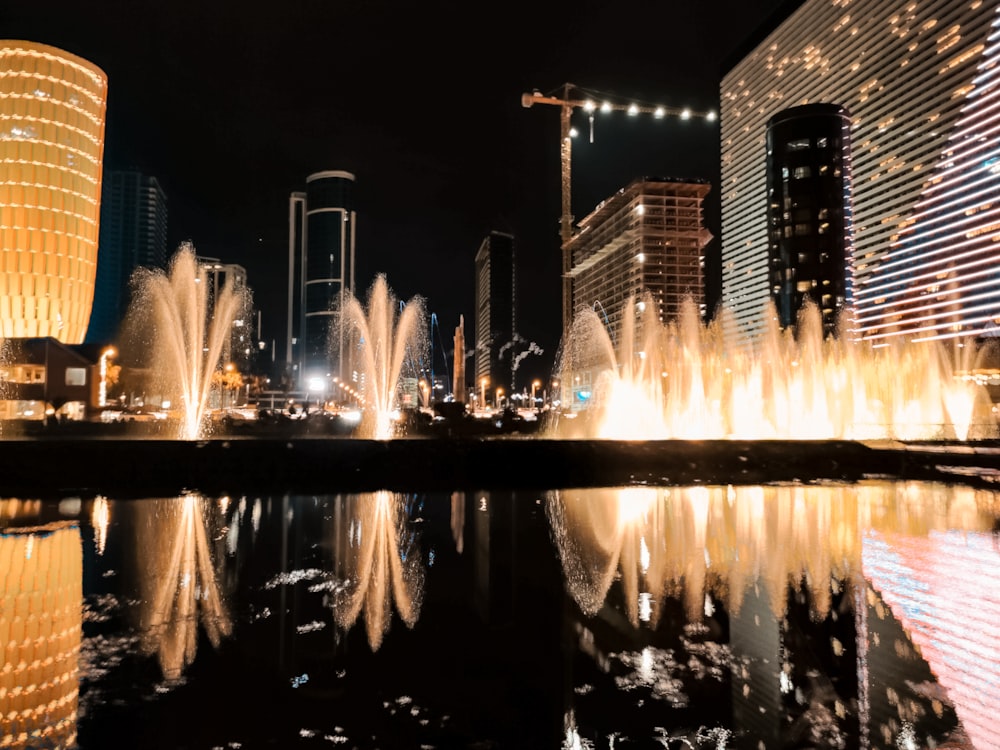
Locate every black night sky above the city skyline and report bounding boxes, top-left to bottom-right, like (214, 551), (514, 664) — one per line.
(0, 0), (783, 382)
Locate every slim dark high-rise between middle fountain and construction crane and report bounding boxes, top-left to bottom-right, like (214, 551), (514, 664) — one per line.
(474, 232), (517, 408)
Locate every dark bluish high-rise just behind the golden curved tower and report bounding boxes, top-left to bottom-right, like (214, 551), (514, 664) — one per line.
(86, 170), (167, 343)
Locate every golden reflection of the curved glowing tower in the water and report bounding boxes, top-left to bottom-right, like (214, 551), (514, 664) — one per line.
(0, 521), (83, 750)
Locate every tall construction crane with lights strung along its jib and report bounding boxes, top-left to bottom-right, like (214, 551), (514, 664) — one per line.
(521, 83), (715, 340)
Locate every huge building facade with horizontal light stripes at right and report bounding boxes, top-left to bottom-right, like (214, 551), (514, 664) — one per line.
(720, 0), (1000, 344)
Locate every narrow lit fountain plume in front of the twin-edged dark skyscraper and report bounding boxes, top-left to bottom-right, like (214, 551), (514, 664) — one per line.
(340, 275), (427, 440)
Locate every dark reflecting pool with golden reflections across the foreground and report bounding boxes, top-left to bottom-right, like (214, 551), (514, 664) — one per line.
(0, 480), (1000, 750)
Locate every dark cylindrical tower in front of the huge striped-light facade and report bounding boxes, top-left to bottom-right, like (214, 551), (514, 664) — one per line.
(767, 104), (854, 335)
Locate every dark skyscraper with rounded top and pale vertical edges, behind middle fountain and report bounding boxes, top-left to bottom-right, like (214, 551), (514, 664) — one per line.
(286, 170), (355, 385)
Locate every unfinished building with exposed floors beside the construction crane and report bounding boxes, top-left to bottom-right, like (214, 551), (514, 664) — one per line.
(568, 177), (712, 344)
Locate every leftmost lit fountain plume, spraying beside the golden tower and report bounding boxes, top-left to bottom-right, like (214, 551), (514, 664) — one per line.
(129, 243), (246, 440)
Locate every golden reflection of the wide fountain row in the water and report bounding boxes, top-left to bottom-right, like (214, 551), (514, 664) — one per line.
(547, 483), (1000, 626)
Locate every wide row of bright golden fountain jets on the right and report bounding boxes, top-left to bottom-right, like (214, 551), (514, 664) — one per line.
(559, 298), (997, 440)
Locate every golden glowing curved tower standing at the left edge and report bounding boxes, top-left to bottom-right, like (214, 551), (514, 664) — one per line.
(0, 40), (108, 344)
